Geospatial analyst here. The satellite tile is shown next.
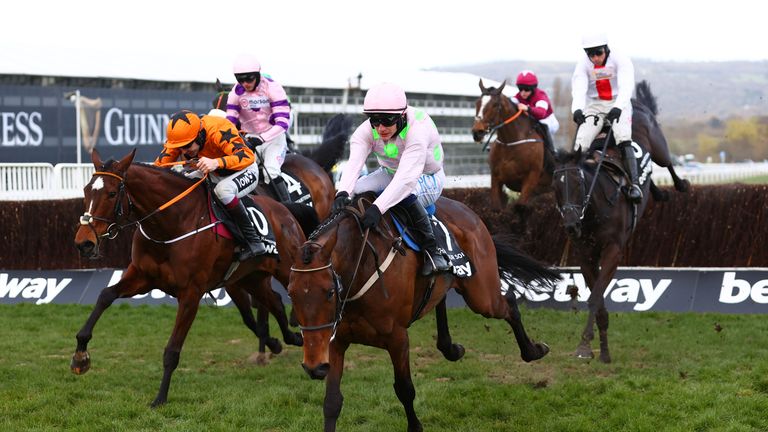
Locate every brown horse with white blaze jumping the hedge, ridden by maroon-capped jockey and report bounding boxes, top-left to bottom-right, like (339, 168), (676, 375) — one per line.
(472, 79), (554, 215)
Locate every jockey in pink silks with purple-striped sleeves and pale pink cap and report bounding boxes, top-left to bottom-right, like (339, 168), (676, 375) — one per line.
(227, 55), (291, 203)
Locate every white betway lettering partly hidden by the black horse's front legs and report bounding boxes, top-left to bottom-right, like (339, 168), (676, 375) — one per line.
(512, 273), (672, 311)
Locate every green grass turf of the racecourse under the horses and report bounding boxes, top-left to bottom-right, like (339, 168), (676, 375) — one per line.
(0, 304), (768, 432)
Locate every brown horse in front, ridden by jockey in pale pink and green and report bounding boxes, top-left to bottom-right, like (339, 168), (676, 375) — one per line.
(288, 193), (559, 432)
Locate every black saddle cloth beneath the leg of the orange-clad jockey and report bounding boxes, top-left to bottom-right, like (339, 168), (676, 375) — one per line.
(208, 189), (277, 256)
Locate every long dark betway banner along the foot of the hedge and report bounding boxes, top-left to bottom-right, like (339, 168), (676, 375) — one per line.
(0, 268), (768, 313)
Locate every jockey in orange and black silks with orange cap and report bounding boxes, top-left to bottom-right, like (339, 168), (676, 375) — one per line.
(155, 111), (266, 261)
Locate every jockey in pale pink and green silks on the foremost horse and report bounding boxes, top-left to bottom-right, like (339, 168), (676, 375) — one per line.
(333, 83), (450, 276)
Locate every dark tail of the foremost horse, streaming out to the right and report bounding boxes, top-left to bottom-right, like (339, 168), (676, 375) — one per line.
(493, 236), (560, 289)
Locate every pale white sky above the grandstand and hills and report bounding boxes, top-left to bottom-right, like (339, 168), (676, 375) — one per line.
(0, 0), (768, 85)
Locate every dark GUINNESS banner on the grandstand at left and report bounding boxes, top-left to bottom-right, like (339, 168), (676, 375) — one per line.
(0, 85), (214, 164)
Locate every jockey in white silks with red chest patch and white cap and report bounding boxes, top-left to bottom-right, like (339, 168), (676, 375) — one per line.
(571, 34), (643, 202)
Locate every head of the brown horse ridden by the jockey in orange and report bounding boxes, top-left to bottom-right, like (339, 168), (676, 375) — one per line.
(75, 149), (136, 258)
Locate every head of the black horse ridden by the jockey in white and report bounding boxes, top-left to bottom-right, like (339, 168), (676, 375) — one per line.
(552, 149), (587, 238)
